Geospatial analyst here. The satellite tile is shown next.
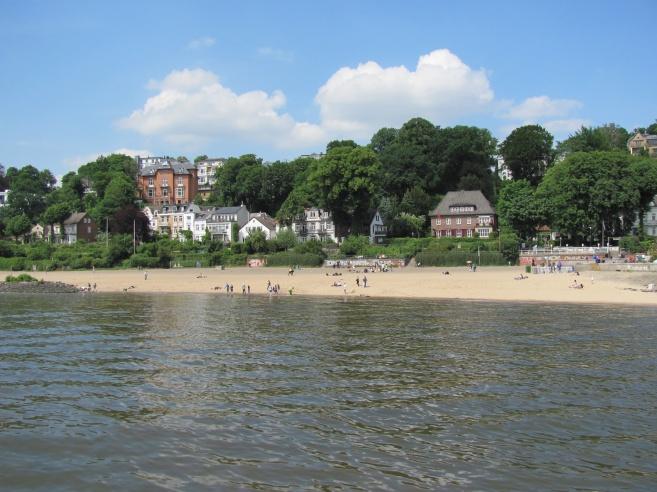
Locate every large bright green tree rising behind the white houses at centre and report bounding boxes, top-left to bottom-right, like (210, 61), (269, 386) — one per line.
(309, 146), (380, 232)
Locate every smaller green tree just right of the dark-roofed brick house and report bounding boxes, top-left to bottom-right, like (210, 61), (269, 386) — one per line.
(496, 179), (542, 238)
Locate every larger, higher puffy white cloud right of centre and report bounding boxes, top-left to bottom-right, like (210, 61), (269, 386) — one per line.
(315, 49), (494, 137)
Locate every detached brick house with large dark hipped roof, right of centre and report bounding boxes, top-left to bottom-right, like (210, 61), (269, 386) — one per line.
(429, 190), (497, 238)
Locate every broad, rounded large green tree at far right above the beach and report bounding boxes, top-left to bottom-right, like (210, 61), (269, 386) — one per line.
(536, 151), (640, 241)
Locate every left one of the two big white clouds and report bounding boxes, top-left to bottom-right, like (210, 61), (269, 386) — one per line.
(119, 69), (326, 148)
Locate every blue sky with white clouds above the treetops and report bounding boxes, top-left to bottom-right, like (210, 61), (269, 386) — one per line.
(0, 0), (657, 181)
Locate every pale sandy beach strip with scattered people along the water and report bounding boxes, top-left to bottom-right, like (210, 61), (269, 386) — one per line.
(6, 266), (657, 305)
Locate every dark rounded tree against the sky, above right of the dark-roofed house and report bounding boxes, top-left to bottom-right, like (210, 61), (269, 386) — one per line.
(500, 125), (554, 186)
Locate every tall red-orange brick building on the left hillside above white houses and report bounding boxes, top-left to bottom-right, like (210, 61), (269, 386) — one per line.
(138, 159), (198, 206)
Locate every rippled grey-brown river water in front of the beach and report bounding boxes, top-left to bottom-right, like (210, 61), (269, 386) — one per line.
(0, 295), (657, 490)
